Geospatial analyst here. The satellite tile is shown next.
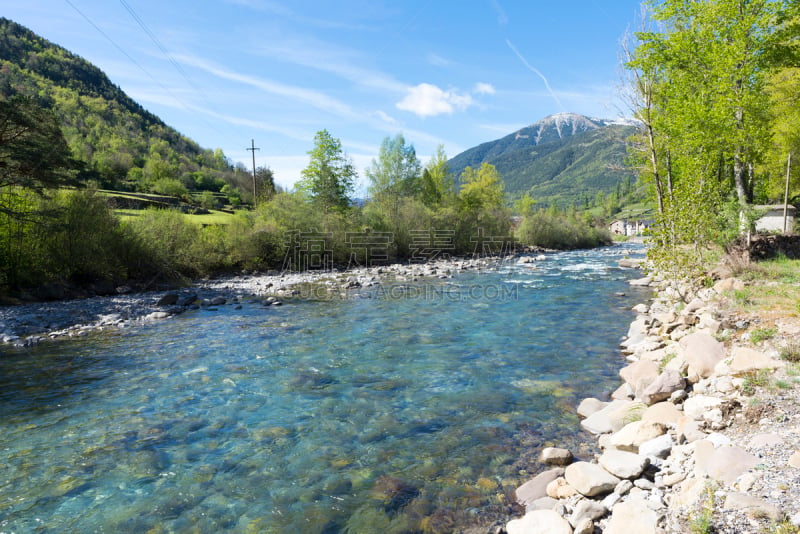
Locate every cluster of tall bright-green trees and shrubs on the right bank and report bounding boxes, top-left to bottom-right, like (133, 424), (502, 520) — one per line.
(623, 0), (800, 272)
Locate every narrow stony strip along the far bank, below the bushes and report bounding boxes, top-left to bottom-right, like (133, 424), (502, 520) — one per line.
(0, 257), (500, 347)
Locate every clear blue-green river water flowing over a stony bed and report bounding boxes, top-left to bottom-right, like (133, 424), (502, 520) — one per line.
(0, 247), (646, 534)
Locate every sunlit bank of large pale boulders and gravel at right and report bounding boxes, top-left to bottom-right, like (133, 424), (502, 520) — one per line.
(506, 266), (800, 534)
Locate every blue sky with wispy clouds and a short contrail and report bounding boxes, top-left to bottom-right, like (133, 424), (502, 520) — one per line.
(0, 0), (640, 193)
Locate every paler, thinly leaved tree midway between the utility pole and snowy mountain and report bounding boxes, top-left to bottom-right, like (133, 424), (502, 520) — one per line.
(367, 134), (422, 201)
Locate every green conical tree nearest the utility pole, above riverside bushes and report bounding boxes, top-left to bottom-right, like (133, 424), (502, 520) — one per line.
(298, 130), (357, 213)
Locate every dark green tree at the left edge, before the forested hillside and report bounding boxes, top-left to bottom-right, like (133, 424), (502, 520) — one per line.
(0, 97), (77, 217)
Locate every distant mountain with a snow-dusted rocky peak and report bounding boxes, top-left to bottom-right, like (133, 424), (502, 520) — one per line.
(448, 113), (636, 207)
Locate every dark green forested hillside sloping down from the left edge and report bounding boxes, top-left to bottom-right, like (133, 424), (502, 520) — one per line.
(0, 17), (252, 201)
